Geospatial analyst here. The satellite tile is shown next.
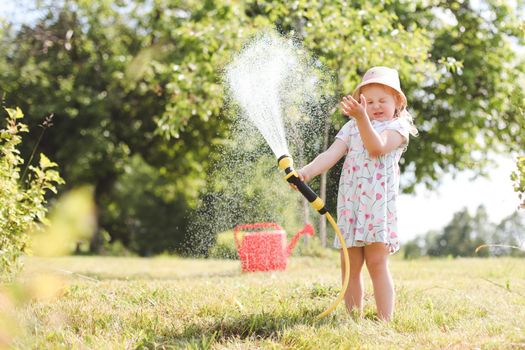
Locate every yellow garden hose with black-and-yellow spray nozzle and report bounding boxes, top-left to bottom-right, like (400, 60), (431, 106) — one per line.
(277, 155), (350, 319)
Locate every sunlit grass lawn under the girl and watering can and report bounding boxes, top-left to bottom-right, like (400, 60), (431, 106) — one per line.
(0, 255), (525, 349)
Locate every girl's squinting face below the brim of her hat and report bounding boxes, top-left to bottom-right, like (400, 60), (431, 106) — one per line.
(361, 84), (398, 120)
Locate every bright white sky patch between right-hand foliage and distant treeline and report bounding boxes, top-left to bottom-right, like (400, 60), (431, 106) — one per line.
(398, 157), (519, 242)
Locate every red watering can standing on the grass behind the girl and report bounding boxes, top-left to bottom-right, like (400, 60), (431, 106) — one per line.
(234, 222), (314, 272)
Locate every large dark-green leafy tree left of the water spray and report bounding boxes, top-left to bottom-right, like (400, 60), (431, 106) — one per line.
(0, 0), (262, 251)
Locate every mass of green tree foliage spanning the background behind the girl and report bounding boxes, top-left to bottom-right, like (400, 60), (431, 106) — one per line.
(0, 0), (525, 254)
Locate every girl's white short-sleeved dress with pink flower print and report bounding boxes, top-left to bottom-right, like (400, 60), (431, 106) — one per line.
(334, 118), (410, 254)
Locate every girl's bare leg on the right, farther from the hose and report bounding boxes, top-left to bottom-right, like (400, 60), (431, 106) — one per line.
(364, 243), (394, 321)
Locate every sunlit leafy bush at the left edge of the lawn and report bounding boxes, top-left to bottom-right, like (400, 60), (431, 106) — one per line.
(0, 108), (64, 280)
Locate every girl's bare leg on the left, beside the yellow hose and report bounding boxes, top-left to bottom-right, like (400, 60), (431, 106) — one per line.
(340, 247), (364, 312)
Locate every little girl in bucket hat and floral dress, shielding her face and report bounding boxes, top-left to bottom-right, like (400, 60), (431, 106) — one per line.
(298, 67), (417, 321)
